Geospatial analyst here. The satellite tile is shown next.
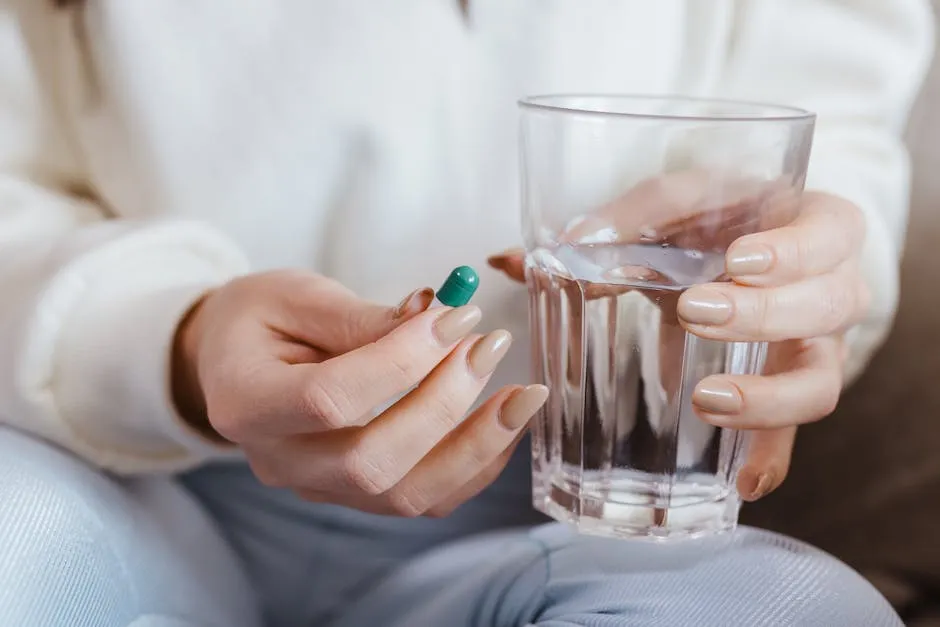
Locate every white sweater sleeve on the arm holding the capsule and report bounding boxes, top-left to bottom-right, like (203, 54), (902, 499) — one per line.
(0, 0), (246, 473)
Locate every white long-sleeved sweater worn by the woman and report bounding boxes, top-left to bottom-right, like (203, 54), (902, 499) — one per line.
(0, 0), (932, 473)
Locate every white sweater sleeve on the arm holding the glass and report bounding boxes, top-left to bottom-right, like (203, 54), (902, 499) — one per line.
(723, 0), (934, 381)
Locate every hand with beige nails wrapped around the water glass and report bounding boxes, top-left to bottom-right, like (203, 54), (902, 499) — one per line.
(490, 192), (869, 501)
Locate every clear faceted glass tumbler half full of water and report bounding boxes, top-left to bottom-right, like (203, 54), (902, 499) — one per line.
(520, 96), (815, 539)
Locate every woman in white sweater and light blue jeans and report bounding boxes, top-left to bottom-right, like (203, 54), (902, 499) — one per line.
(0, 0), (931, 627)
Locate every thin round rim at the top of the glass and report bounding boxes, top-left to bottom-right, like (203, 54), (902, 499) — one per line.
(517, 93), (816, 122)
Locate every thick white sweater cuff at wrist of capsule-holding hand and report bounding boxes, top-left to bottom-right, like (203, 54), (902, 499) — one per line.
(27, 225), (247, 474)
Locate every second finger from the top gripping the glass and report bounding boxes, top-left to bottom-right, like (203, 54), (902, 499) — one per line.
(678, 264), (868, 342)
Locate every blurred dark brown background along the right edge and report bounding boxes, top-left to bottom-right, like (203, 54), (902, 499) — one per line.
(743, 0), (940, 627)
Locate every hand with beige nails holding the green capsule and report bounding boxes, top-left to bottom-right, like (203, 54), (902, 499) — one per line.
(173, 271), (548, 516)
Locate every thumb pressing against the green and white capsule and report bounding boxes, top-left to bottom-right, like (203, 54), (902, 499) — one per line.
(323, 287), (434, 355)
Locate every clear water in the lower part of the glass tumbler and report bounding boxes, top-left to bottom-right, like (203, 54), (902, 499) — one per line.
(526, 243), (765, 538)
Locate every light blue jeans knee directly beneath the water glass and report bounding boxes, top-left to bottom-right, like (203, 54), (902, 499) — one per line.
(520, 529), (902, 627)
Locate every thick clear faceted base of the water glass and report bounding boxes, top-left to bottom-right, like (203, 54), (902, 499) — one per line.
(533, 469), (741, 541)
